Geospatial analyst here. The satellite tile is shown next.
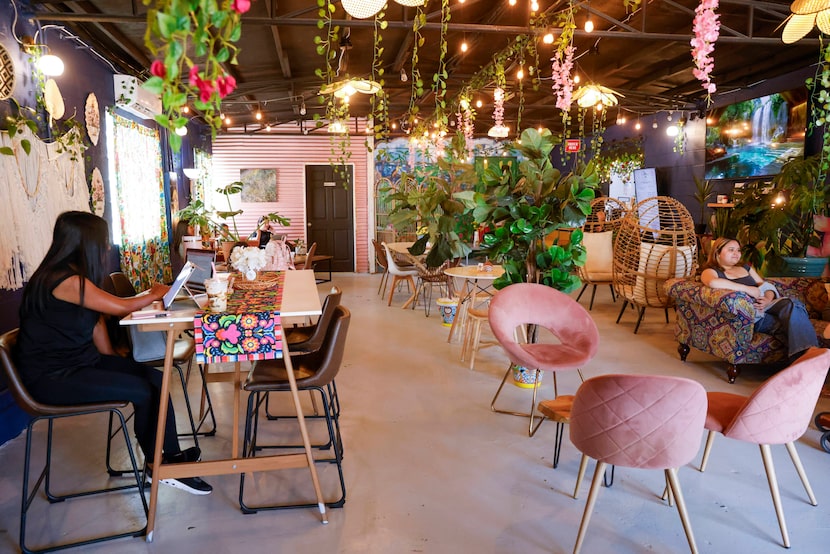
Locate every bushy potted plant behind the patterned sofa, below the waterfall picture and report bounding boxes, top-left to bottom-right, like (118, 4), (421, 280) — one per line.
(733, 154), (830, 276)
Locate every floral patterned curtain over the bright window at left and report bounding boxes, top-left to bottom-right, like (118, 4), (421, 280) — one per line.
(111, 110), (173, 290)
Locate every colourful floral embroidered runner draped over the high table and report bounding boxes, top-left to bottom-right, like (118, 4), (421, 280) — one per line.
(193, 272), (285, 364)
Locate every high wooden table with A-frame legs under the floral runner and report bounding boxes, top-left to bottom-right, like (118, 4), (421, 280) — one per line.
(121, 271), (328, 542)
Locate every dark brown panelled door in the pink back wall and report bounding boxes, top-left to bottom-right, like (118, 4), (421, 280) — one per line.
(305, 165), (355, 272)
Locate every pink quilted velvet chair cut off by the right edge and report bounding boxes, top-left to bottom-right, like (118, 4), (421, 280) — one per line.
(700, 348), (830, 548)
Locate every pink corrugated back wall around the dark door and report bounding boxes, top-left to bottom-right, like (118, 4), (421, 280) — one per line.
(213, 135), (371, 273)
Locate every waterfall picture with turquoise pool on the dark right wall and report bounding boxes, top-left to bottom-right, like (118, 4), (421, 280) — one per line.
(706, 87), (807, 179)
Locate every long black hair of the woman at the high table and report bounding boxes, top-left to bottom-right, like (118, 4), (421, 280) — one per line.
(21, 212), (109, 312)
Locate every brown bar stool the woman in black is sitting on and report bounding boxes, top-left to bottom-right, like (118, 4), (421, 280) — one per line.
(0, 329), (148, 553)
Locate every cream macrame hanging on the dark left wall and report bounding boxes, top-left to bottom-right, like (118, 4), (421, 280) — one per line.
(0, 128), (89, 290)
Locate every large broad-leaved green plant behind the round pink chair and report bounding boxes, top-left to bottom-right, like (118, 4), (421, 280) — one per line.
(474, 128), (599, 292)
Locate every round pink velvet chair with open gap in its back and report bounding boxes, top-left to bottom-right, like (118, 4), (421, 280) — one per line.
(489, 283), (599, 438)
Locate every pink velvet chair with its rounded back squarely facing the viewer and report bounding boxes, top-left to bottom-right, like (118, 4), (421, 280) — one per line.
(571, 375), (706, 554)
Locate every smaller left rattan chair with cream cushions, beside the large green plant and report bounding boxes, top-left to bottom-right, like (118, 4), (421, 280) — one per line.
(576, 197), (628, 310)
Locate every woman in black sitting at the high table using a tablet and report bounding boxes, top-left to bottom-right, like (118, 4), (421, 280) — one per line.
(15, 212), (212, 494)
